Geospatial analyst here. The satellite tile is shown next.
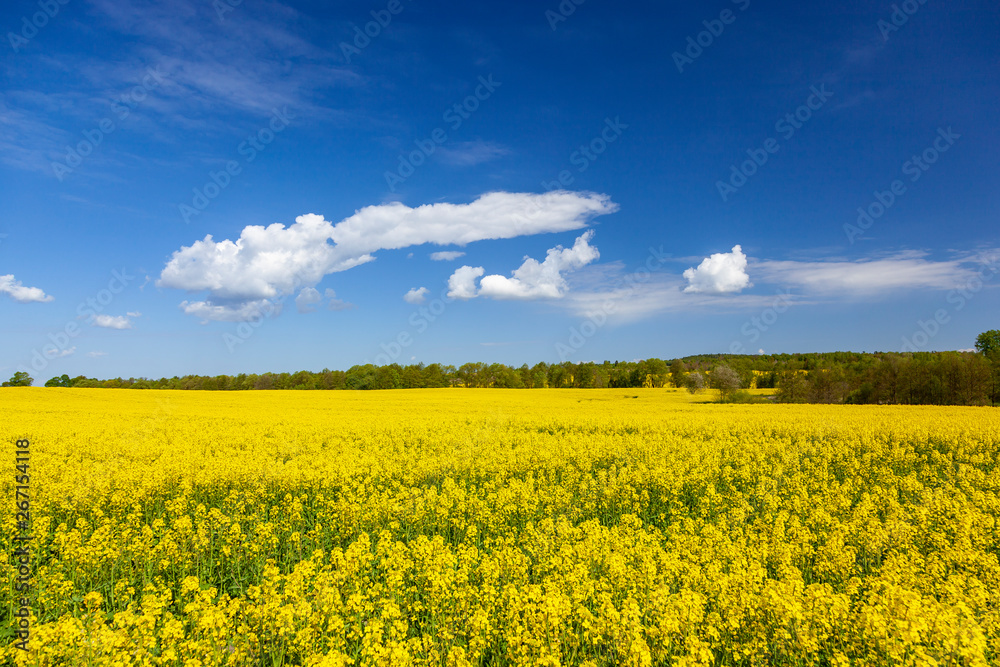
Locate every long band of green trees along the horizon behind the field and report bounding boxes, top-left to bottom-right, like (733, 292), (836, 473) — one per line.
(21, 332), (1000, 405)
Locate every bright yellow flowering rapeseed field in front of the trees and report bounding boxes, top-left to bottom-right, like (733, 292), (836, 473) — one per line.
(0, 388), (1000, 667)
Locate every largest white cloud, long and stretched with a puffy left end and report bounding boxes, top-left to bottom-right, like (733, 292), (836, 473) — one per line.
(156, 191), (618, 321)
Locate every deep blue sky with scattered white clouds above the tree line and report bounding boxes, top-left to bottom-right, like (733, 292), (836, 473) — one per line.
(0, 0), (1000, 382)
